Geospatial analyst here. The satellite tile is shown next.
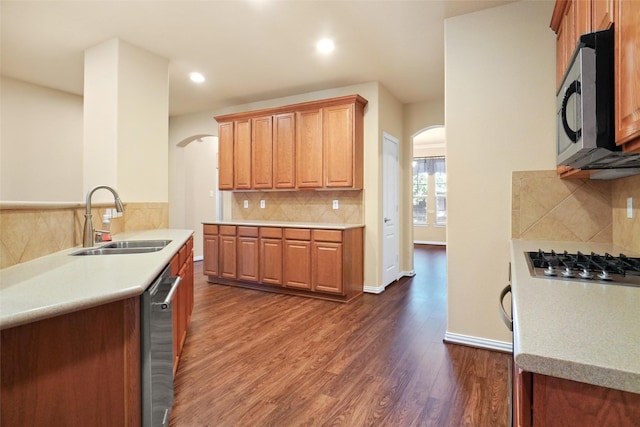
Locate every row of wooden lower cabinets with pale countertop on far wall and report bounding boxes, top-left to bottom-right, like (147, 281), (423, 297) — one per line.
(203, 221), (364, 302)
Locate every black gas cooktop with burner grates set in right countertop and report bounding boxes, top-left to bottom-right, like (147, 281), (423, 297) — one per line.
(525, 249), (640, 287)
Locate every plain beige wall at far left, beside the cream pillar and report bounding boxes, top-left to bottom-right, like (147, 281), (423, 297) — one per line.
(0, 77), (84, 202)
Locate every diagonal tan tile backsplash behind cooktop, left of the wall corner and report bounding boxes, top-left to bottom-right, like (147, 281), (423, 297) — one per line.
(511, 171), (613, 243)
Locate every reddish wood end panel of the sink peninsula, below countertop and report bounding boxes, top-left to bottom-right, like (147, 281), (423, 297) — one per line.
(0, 297), (141, 427)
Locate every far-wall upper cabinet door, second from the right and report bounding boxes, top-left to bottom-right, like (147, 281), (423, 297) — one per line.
(296, 108), (323, 188)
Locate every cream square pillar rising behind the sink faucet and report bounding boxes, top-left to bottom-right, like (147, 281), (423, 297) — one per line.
(84, 39), (169, 202)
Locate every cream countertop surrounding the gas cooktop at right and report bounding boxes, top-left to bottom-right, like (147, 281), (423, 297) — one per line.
(511, 240), (640, 393)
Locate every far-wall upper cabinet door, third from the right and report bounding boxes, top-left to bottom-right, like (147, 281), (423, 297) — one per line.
(273, 113), (296, 188)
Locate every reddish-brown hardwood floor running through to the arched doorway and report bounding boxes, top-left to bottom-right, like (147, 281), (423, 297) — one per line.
(170, 245), (509, 427)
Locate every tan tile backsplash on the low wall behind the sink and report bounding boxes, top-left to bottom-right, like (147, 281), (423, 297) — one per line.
(0, 203), (169, 269)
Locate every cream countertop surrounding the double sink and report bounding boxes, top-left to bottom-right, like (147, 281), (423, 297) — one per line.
(0, 229), (193, 329)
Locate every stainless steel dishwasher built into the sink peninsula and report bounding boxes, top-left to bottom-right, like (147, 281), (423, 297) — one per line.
(140, 266), (180, 427)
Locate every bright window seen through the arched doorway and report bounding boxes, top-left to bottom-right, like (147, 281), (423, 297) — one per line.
(413, 157), (447, 225)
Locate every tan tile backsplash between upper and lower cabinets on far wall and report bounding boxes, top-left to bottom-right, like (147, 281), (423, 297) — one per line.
(231, 190), (364, 224)
